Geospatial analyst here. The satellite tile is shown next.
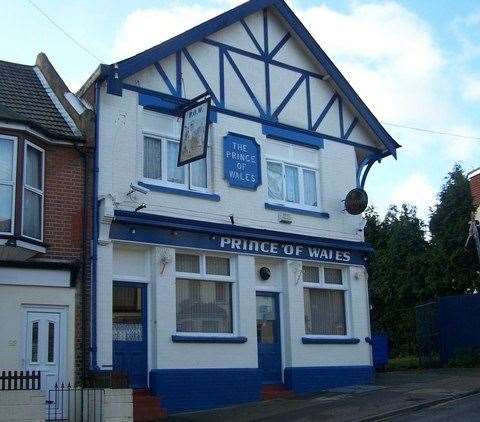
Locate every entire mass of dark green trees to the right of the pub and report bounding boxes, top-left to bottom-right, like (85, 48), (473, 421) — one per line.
(365, 165), (480, 357)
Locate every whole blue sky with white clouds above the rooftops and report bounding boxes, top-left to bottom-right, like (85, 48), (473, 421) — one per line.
(0, 0), (480, 224)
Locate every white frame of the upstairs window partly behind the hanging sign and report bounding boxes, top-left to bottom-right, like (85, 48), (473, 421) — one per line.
(141, 131), (211, 193)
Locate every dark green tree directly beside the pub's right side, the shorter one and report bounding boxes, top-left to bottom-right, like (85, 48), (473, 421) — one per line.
(365, 204), (428, 355)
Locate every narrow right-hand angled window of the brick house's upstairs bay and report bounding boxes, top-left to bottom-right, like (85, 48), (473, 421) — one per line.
(22, 142), (45, 240)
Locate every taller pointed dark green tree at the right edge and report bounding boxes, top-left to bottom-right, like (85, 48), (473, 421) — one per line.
(426, 164), (480, 297)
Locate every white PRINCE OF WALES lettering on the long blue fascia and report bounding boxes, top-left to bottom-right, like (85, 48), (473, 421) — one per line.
(219, 236), (350, 263)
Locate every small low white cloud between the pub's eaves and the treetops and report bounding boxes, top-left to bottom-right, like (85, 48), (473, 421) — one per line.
(390, 173), (436, 221)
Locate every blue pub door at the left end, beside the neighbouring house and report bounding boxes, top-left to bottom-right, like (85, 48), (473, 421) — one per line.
(112, 283), (148, 388)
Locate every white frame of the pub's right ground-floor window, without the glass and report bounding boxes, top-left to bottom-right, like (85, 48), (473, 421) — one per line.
(302, 262), (353, 339)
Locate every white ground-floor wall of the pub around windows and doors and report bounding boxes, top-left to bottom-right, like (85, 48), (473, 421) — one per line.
(109, 242), (371, 369)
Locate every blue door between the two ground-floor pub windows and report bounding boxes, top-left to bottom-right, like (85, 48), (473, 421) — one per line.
(257, 292), (282, 384)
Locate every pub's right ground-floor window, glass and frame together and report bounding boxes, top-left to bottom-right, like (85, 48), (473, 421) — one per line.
(303, 265), (348, 337)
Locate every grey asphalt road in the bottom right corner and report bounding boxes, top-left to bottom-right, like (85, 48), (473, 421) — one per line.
(384, 394), (480, 422)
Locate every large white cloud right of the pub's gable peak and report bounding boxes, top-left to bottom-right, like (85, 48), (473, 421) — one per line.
(298, 2), (451, 125)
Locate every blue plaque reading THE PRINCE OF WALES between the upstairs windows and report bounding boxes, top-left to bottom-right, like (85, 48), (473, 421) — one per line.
(223, 132), (262, 190)
